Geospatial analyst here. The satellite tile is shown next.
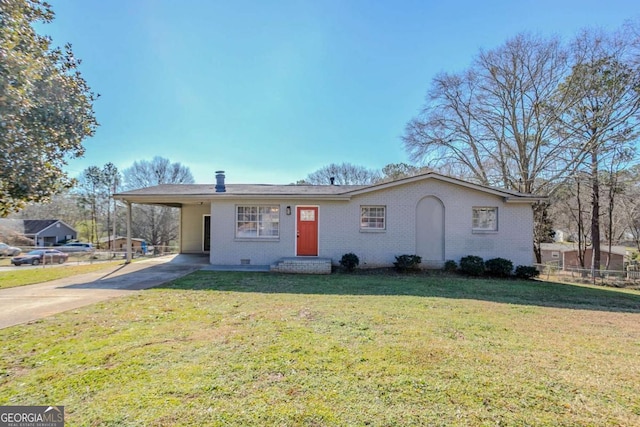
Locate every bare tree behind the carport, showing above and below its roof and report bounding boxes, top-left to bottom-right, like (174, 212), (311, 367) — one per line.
(123, 156), (195, 246)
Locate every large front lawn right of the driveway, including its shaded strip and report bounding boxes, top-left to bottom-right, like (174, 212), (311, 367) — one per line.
(0, 272), (640, 426)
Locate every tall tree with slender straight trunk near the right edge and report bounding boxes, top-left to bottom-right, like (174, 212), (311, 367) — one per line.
(557, 27), (640, 276)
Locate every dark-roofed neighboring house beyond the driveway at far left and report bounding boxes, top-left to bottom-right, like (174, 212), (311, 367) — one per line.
(0, 219), (78, 246)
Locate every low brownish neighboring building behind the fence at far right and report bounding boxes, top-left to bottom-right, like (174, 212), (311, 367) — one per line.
(540, 243), (631, 270)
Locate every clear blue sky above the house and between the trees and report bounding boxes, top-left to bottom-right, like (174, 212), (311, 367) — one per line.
(41, 0), (640, 184)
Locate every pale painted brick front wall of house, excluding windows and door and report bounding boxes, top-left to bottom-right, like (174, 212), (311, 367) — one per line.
(182, 179), (533, 267)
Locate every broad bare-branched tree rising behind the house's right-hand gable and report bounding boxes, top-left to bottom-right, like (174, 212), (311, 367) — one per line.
(403, 34), (576, 193)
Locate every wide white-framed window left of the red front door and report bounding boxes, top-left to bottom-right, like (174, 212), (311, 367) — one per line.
(236, 205), (280, 239)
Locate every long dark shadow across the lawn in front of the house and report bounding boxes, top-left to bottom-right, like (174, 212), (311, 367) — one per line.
(158, 271), (640, 313)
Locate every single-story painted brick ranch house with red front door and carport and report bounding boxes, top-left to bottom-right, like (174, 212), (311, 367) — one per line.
(114, 171), (544, 271)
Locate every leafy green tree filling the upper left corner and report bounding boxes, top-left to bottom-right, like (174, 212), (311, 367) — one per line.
(0, 0), (97, 216)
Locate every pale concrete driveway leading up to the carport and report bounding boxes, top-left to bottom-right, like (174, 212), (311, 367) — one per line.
(0, 255), (209, 328)
